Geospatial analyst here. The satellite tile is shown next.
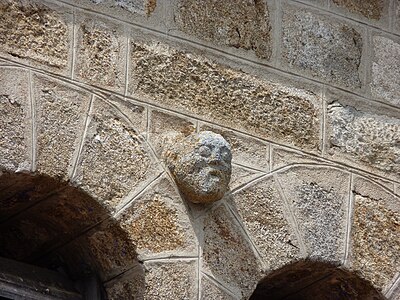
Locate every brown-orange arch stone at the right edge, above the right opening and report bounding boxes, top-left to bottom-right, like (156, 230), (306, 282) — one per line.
(351, 178), (400, 290)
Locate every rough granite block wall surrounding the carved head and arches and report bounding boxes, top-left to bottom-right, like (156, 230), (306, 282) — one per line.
(0, 0), (400, 299)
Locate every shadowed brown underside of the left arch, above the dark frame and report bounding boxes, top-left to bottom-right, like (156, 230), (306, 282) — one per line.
(0, 173), (144, 299)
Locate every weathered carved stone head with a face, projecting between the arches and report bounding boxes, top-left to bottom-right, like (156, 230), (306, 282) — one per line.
(165, 131), (232, 203)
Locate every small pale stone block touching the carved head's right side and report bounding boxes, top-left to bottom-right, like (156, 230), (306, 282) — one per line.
(200, 124), (269, 171)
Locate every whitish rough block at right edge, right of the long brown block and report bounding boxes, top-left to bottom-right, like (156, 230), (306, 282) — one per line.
(327, 102), (400, 177)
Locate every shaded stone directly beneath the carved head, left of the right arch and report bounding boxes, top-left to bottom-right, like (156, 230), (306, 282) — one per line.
(201, 206), (262, 299)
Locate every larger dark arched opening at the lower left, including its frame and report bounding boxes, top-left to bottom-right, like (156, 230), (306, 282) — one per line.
(0, 173), (138, 299)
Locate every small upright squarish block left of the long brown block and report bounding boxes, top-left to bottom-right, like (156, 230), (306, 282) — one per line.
(75, 14), (127, 92)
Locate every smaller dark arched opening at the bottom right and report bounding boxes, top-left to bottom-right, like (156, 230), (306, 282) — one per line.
(250, 261), (385, 300)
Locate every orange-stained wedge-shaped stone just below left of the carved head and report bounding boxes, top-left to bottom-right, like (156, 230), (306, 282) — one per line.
(119, 177), (197, 258)
